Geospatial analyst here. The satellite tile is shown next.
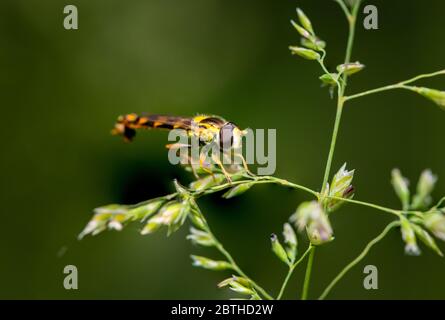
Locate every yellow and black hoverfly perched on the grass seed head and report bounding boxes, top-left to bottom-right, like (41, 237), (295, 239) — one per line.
(112, 113), (251, 182)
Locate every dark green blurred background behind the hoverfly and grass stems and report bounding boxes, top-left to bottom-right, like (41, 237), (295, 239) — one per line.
(0, 0), (445, 299)
